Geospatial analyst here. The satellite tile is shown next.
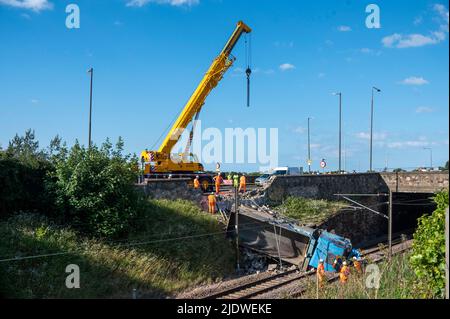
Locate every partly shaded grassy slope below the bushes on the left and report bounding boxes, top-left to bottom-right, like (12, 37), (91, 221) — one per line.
(0, 200), (234, 298)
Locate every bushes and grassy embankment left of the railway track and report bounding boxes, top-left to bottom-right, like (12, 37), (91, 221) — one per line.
(0, 131), (234, 298)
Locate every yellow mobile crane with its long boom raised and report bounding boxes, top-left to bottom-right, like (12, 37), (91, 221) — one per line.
(141, 21), (252, 190)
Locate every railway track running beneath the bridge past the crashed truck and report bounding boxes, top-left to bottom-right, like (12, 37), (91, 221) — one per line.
(205, 239), (412, 299)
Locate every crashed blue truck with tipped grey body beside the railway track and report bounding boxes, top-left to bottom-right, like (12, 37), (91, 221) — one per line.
(227, 206), (358, 272)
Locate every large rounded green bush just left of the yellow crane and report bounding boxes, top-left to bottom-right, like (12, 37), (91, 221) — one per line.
(47, 139), (142, 237)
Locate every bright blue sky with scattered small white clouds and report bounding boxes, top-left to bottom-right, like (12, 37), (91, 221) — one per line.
(0, 0), (449, 171)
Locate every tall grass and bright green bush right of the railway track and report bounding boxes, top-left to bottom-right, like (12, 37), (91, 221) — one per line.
(302, 191), (449, 299)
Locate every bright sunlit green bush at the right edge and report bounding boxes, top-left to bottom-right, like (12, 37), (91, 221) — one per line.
(411, 191), (448, 298)
